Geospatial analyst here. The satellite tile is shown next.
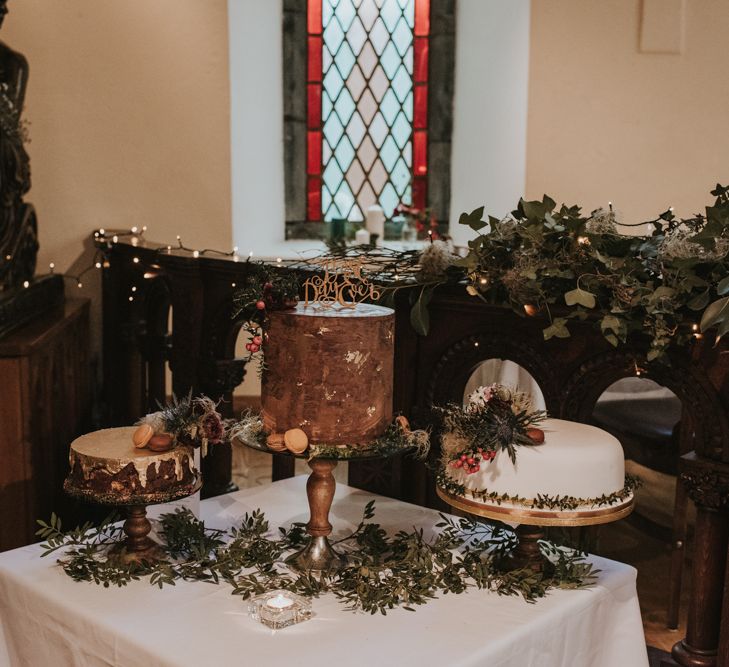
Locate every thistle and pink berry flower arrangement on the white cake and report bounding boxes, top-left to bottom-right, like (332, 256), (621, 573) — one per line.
(437, 384), (547, 473)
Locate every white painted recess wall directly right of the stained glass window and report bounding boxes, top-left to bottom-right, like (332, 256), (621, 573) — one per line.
(450, 0), (530, 245)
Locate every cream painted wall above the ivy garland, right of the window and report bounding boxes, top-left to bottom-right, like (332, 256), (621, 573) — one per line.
(527, 0), (729, 222)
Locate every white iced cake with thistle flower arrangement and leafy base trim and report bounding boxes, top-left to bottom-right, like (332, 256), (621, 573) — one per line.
(436, 384), (639, 512)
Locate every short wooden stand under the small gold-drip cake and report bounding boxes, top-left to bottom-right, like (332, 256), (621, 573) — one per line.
(63, 475), (202, 565)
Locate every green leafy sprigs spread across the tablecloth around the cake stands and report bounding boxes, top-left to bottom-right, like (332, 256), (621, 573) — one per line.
(37, 501), (596, 614)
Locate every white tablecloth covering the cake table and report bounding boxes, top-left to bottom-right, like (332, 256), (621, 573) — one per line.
(0, 477), (648, 667)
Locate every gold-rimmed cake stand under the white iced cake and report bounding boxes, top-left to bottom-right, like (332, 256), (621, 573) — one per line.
(436, 486), (634, 572)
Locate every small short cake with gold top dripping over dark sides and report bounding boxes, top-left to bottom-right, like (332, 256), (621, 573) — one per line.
(65, 426), (200, 504)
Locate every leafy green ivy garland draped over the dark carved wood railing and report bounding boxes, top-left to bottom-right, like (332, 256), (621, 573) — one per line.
(457, 184), (729, 361)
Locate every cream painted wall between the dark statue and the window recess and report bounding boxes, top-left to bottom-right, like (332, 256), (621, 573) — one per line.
(0, 0), (232, 274)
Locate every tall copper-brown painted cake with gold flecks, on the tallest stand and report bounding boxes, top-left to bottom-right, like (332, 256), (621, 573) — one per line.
(261, 302), (395, 446)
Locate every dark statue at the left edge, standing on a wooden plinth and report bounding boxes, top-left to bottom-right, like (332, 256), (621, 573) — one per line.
(0, 0), (38, 290)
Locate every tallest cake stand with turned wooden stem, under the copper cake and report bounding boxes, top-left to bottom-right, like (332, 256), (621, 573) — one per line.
(239, 438), (398, 574)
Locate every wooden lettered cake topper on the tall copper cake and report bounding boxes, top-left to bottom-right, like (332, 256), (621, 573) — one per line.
(304, 257), (381, 308)
